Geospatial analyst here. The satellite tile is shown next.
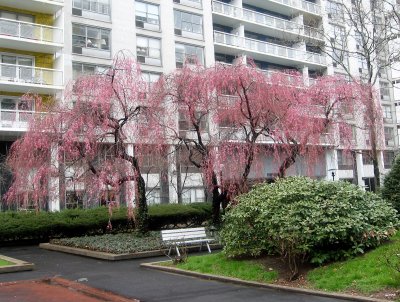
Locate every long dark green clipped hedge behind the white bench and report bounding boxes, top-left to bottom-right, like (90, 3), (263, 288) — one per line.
(0, 203), (211, 244)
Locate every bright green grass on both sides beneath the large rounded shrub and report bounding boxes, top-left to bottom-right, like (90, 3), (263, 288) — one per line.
(165, 232), (400, 294)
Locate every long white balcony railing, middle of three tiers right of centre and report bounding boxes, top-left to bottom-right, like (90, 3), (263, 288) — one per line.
(213, 1), (324, 40)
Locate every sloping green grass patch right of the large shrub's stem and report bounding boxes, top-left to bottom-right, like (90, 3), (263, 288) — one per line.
(307, 232), (400, 294)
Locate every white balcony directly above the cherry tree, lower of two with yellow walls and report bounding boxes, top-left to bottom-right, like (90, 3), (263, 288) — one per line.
(0, 63), (64, 94)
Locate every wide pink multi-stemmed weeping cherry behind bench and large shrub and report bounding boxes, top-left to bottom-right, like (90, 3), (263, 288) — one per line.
(159, 60), (355, 223)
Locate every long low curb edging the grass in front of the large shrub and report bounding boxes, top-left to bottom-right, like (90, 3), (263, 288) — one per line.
(140, 261), (389, 302)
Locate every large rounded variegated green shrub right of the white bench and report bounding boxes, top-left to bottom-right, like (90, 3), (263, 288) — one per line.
(220, 177), (398, 278)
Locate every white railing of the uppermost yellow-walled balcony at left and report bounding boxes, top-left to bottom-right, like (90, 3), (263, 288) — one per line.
(0, 18), (63, 44)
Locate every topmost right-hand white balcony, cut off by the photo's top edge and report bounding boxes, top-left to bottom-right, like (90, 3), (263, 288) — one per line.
(243, 0), (322, 17)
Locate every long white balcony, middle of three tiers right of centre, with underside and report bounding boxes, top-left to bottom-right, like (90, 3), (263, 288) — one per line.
(213, 1), (324, 41)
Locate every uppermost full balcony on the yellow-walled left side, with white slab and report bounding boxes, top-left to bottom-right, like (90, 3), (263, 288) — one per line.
(0, 18), (64, 53)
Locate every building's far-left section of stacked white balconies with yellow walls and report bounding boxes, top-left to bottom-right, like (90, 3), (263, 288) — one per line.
(0, 0), (65, 206)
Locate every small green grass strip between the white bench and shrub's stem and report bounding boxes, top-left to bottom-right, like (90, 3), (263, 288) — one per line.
(164, 253), (278, 283)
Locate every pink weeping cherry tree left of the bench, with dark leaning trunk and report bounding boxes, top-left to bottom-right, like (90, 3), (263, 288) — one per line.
(7, 52), (162, 231)
